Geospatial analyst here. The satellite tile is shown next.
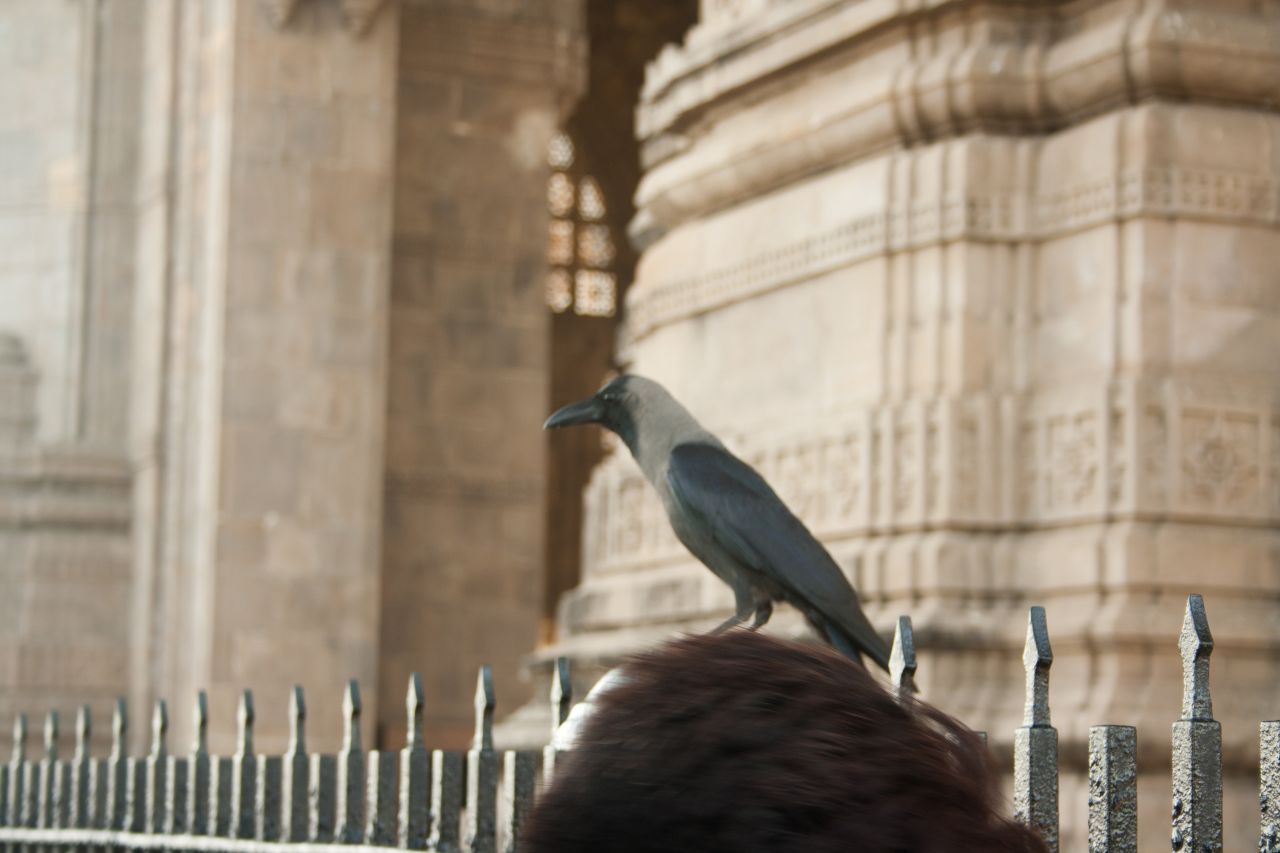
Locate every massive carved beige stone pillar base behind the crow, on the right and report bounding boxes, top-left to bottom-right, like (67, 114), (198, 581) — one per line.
(555, 0), (1280, 849)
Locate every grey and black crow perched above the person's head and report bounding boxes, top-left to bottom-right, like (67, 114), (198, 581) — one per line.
(544, 375), (888, 669)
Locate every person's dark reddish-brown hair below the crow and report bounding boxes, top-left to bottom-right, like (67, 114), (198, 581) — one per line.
(520, 630), (1047, 853)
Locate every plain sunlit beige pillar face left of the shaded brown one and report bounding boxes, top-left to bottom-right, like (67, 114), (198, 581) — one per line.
(137, 0), (398, 751)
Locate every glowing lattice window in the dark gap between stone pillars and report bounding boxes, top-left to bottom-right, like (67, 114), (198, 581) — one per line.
(547, 133), (618, 316)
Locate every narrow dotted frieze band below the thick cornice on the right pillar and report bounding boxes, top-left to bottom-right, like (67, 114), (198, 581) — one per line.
(620, 159), (1280, 351)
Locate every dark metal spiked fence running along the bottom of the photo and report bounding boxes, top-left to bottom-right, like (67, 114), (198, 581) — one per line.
(0, 596), (1259, 853)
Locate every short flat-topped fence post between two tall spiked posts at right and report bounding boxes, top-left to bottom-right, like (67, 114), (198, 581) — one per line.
(1089, 726), (1138, 853)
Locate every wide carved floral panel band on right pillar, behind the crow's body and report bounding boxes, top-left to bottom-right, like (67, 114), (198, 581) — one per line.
(582, 384), (1280, 576)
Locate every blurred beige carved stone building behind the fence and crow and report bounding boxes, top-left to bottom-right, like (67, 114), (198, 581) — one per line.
(0, 0), (1280, 848)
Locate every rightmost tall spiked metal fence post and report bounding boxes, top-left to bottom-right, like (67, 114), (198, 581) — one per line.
(1170, 594), (1222, 853)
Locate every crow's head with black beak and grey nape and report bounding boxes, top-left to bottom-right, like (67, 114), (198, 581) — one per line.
(543, 375), (703, 459)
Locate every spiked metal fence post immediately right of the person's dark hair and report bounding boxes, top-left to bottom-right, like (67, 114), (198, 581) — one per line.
(1014, 607), (1057, 853)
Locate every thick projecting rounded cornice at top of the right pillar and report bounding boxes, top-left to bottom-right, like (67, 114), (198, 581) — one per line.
(634, 0), (1280, 229)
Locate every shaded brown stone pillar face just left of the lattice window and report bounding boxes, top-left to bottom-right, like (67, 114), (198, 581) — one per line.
(379, 0), (584, 747)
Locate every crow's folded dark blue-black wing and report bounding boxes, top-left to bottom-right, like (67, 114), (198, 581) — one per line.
(667, 443), (888, 669)
